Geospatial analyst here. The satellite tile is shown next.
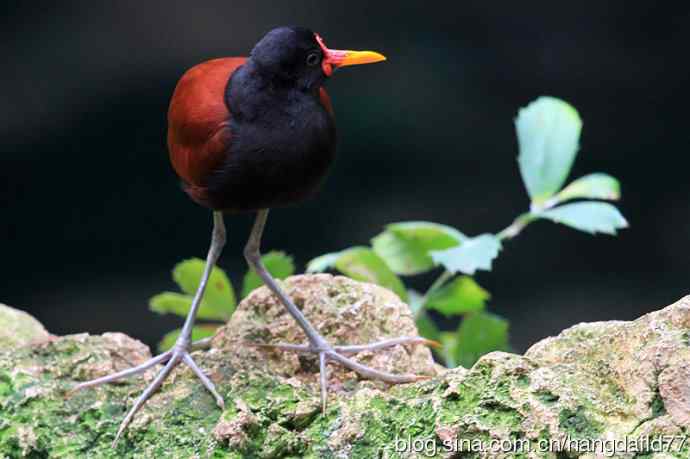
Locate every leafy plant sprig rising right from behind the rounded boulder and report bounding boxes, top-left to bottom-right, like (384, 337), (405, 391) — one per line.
(307, 97), (627, 367)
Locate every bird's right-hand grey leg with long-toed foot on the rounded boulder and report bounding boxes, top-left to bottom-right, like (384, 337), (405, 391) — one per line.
(244, 209), (431, 411)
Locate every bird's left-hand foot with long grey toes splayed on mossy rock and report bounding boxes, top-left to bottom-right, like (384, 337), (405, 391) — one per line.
(70, 339), (225, 448)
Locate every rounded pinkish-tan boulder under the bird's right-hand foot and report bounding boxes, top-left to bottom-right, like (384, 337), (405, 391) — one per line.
(213, 274), (438, 392)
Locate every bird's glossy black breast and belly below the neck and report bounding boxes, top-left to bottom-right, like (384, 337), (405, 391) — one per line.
(207, 69), (336, 212)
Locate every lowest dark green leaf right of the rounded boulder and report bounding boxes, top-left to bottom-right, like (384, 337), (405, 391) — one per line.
(456, 311), (510, 368)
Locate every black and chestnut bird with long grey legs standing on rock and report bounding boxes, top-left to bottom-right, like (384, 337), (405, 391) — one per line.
(74, 26), (435, 445)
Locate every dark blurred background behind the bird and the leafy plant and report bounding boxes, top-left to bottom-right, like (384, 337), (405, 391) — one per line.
(0, 0), (690, 350)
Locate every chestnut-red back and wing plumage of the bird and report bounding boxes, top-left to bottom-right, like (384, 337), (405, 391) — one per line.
(168, 57), (333, 203)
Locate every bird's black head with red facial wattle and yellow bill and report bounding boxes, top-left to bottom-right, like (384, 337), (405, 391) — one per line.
(250, 27), (386, 90)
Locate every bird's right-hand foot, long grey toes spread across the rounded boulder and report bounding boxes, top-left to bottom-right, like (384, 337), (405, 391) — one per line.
(248, 336), (440, 412)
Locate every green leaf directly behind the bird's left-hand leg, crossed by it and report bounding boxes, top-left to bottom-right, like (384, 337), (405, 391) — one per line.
(173, 258), (237, 320)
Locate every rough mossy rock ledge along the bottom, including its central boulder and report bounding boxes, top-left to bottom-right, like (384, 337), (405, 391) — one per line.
(0, 275), (690, 459)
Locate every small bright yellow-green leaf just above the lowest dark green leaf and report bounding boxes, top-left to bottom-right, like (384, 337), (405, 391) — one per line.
(426, 276), (491, 317)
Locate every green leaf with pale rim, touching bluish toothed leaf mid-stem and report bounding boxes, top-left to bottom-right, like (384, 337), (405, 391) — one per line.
(371, 222), (466, 276)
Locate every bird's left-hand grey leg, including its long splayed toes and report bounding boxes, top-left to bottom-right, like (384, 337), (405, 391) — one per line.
(71, 212), (225, 446)
